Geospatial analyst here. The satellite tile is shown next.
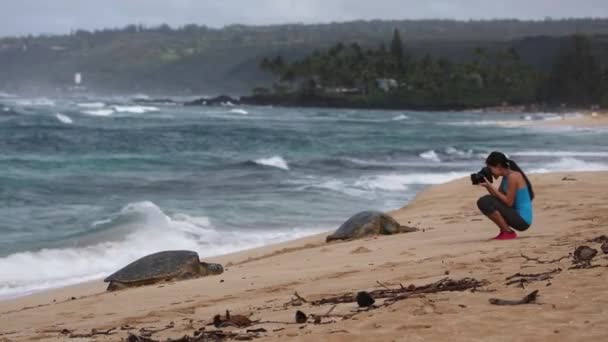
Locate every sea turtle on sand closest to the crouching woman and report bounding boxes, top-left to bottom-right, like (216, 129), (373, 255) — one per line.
(326, 211), (418, 242)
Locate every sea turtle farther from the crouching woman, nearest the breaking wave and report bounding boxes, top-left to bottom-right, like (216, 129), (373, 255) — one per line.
(104, 251), (224, 291)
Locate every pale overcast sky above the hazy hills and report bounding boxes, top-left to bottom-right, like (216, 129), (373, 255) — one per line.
(0, 0), (608, 36)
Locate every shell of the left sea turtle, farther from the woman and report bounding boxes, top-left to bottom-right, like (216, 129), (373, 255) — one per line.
(104, 251), (200, 283)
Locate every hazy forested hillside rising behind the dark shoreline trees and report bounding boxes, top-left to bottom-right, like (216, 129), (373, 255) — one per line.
(0, 19), (608, 102)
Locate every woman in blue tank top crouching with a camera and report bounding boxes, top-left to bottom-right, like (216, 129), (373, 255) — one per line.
(477, 152), (534, 240)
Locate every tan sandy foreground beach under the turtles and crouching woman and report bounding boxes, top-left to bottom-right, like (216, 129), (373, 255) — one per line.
(0, 172), (608, 341)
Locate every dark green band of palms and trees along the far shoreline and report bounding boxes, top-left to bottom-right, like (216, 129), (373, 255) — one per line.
(253, 30), (608, 108)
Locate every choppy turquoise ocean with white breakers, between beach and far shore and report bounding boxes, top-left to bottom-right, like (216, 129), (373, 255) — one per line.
(0, 97), (608, 298)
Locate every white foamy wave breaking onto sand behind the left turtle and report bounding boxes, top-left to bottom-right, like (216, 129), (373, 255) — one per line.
(0, 202), (325, 298)
